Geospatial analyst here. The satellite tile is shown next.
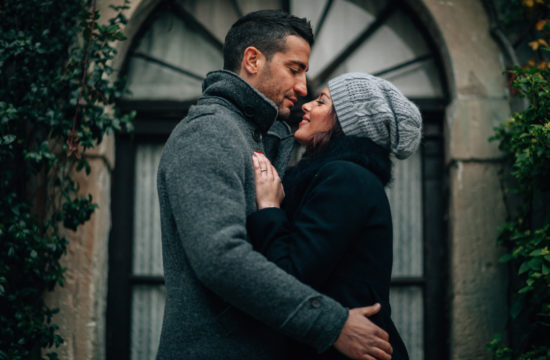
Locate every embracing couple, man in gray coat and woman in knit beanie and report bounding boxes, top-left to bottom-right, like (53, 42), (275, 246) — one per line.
(157, 10), (422, 360)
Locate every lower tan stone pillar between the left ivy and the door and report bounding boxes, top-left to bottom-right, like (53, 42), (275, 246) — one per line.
(46, 136), (114, 360)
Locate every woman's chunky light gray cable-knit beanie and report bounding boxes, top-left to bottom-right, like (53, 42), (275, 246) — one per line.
(328, 73), (422, 159)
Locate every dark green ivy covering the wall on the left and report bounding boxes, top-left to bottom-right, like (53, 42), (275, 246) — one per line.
(0, 0), (132, 360)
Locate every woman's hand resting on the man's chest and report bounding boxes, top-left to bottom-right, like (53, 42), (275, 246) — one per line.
(252, 152), (285, 210)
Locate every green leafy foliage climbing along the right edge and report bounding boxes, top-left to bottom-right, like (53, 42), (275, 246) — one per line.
(489, 0), (550, 360)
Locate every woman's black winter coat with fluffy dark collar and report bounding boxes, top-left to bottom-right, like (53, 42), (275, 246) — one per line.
(247, 136), (408, 360)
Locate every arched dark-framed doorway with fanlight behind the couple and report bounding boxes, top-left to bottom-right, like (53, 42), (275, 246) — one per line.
(107, 0), (447, 359)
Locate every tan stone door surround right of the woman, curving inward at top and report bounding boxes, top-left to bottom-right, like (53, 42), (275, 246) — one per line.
(424, 0), (510, 360)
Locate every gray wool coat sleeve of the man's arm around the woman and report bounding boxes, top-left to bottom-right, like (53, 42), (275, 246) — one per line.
(161, 120), (348, 351)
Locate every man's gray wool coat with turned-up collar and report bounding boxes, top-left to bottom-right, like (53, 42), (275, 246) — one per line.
(157, 71), (348, 360)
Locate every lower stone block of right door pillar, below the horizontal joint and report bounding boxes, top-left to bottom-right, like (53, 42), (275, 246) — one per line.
(449, 162), (508, 360)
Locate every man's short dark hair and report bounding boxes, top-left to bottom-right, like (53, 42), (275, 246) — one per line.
(223, 10), (313, 72)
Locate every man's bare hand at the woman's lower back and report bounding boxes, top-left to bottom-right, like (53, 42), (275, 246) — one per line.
(334, 304), (393, 360)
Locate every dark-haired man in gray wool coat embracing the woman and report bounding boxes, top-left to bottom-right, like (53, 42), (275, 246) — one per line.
(158, 10), (391, 360)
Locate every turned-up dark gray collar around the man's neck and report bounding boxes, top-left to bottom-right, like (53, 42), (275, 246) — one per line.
(202, 70), (278, 132)
